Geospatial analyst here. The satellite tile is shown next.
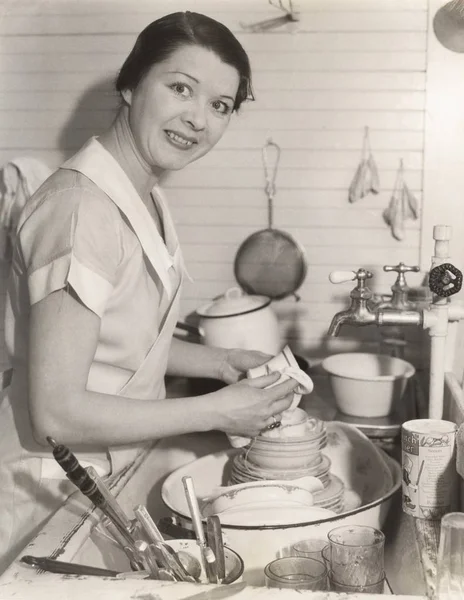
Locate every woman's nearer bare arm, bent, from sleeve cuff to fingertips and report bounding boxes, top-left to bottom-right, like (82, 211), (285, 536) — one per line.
(29, 290), (296, 446)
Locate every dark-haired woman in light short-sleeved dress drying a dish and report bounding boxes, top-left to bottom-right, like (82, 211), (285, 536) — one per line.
(0, 13), (297, 565)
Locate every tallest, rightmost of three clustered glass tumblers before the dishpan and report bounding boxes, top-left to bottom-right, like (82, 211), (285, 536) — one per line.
(327, 525), (385, 587)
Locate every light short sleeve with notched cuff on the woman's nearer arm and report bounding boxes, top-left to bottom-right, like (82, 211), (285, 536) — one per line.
(18, 179), (121, 317)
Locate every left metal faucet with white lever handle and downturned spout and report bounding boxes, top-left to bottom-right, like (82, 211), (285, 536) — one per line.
(327, 268), (424, 337)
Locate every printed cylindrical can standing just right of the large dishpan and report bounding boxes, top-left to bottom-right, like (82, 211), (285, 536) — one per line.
(401, 419), (457, 520)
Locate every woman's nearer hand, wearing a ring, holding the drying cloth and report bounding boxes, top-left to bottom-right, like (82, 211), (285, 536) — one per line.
(210, 373), (298, 437)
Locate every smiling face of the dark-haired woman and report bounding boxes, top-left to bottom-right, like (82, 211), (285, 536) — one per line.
(123, 45), (239, 170)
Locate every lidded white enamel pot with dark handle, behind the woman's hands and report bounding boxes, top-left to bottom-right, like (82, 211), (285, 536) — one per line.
(177, 287), (282, 356)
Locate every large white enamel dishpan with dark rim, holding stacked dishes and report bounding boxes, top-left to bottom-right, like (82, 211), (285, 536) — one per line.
(158, 423), (401, 586)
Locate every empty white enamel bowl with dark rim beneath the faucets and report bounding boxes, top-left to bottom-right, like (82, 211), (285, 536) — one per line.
(322, 352), (415, 417)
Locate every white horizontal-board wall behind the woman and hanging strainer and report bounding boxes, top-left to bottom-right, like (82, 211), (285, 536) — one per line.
(0, 0), (428, 370)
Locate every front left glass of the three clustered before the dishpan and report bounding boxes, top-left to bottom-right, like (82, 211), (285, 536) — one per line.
(264, 556), (327, 591)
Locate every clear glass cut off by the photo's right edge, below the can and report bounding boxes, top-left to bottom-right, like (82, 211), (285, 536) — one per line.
(436, 512), (464, 600)
